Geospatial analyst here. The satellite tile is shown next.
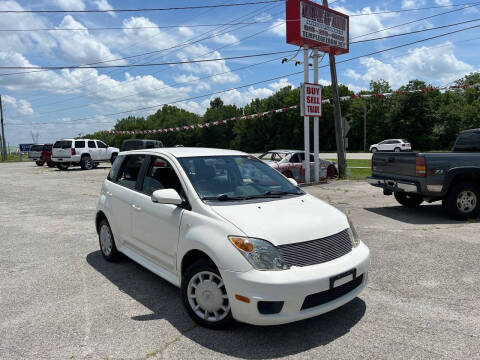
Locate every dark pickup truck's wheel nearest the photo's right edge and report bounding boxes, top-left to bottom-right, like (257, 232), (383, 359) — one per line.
(443, 182), (480, 220)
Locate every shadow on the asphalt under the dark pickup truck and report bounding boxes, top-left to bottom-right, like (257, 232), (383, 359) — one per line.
(365, 205), (476, 225)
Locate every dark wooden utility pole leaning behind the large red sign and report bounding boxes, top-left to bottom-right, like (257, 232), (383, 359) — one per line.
(323, 0), (347, 179)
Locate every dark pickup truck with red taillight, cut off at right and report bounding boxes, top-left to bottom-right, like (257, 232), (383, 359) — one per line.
(368, 129), (480, 220)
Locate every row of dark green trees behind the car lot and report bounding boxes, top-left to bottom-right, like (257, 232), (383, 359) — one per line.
(86, 73), (480, 152)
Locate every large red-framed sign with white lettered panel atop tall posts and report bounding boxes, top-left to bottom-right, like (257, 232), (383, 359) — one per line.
(285, 0), (349, 55)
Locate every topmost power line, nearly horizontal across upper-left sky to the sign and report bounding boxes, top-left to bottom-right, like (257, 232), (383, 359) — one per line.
(0, 0), (284, 14)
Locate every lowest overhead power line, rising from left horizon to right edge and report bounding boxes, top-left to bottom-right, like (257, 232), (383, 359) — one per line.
(7, 25), (480, 126)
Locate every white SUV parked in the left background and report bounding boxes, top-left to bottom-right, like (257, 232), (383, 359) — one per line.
(52, 139), (119, 170)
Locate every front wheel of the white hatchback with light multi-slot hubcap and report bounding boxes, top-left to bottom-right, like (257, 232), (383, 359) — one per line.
(181, 260), (233, 329)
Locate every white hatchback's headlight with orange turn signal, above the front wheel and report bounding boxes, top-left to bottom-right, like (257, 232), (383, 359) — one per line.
(228, 236), (289, 270)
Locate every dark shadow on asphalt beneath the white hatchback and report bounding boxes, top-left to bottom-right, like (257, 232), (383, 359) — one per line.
(87, 251), (366, 359)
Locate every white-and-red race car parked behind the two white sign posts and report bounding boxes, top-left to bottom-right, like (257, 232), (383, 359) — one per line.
(258, 150), (338, 182)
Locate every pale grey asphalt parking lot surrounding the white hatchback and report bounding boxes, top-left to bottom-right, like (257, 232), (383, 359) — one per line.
(0, 163), (480, 359)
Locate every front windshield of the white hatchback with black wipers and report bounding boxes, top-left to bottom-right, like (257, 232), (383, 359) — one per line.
(179, 156), (304, 201)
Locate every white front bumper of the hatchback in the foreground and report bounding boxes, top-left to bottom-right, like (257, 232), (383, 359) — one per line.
(220, 243), (370, 325)
